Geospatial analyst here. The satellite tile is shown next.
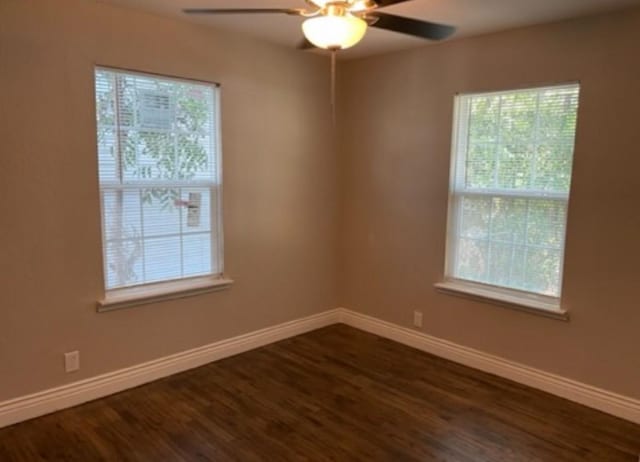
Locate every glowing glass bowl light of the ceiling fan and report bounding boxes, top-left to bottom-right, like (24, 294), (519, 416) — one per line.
(302, 14), (367, 50)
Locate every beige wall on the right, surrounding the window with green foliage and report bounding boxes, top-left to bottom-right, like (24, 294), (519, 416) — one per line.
(339, 6), (640, 398)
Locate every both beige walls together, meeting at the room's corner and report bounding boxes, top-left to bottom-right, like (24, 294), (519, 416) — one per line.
(0, 0), (640, 401)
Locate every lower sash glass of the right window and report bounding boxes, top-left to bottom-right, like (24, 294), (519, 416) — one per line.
(455, 196), (567, 295)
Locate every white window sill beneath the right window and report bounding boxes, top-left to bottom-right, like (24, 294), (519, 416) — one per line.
(435, 281), (569, 321)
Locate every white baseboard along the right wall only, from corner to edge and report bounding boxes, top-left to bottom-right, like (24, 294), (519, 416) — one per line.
(339, 309), (640, 424)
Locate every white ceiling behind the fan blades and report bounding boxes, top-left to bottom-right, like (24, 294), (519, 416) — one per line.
(99, 0), (640, 58)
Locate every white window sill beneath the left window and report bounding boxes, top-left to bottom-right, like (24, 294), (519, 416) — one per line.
(98, 277), (233, 312)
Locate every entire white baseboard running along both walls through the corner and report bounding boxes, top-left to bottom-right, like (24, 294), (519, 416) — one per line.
(0, 308), (640, 428)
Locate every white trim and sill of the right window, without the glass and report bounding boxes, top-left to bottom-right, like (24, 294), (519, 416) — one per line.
(434, 81), (581, 321)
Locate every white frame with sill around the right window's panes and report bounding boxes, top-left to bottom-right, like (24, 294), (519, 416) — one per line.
(435, 82), (579, 320)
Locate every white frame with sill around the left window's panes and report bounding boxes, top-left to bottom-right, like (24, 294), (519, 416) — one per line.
(94, 66), (233, 311)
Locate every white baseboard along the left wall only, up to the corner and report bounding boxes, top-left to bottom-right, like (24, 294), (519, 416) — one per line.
(0, 310), (340, 428)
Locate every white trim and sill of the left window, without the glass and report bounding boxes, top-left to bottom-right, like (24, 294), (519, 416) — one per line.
(92, 64), (226, 304)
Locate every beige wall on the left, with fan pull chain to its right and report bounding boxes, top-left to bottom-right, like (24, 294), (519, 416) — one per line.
(0, 0), (337, 401)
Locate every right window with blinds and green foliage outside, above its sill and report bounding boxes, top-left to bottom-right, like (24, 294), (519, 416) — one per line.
(445, 85), (579, 309)
